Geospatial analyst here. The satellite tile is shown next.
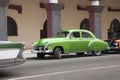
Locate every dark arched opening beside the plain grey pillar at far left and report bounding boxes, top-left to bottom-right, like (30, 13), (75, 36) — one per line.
(7, 16), (18, 36)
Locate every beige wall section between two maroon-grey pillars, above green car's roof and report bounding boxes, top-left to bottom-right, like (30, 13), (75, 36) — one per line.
(60, 0), (90, 29)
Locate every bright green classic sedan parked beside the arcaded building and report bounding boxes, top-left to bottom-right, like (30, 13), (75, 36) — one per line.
(32, 30), (109, 59)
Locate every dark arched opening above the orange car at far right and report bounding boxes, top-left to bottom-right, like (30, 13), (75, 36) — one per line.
(108, 19), (120, 39)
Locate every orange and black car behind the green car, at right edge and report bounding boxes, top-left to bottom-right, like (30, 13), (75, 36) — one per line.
(105, 39), (120, 53)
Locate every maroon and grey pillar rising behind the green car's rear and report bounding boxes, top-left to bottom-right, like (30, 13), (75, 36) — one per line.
(88, 6), (104, 39)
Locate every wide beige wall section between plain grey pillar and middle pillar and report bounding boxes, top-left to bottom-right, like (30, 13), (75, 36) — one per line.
(7, 0), (47, 48)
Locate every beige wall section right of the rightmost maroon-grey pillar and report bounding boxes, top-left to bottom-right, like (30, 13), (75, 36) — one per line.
(101, 0), (120, 40)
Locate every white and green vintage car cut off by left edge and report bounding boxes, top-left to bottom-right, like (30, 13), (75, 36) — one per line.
(0, 41), (25, 68)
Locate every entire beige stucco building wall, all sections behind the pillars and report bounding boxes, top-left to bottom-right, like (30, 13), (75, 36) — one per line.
(7, 0), (120, 48)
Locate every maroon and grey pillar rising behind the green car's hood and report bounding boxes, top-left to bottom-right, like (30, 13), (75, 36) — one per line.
(44, 3), (63, 37)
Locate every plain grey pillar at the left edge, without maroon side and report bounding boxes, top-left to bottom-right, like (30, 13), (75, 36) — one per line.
(0, 0), (10, 41)
